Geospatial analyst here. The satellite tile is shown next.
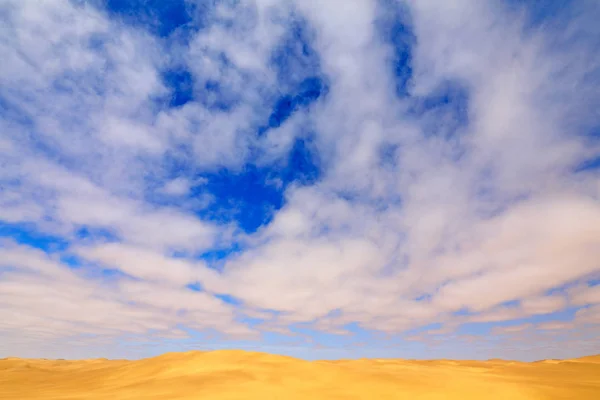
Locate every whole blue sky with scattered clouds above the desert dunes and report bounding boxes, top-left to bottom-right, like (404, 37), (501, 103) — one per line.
(0, 0), (600, 360)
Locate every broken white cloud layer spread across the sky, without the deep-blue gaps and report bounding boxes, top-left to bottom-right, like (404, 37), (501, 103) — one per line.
(0, 0), (600, 358)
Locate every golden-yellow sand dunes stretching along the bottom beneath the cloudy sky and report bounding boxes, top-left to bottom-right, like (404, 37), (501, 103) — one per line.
(0, 351), (600, 400)
